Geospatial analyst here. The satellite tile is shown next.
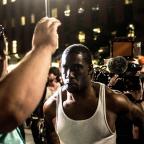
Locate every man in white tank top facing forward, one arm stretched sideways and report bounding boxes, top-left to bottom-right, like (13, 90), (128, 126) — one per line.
(44, 44), (144, 144)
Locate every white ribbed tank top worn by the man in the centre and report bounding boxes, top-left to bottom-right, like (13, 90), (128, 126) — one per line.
(55, 83), (116, 144)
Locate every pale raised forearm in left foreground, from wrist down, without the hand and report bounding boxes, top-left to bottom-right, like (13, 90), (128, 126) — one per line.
(0, 47), (52, 131)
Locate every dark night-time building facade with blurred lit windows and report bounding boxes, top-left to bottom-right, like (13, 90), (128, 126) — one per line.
(0, 0), (144, 59)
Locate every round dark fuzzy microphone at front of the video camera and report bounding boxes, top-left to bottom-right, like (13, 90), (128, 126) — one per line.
(108, 56), (128, 75)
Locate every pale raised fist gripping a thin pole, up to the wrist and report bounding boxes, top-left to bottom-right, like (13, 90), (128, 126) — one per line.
(32, 17), (61, 53)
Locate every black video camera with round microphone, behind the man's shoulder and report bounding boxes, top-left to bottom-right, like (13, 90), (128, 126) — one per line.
(108, 56), (142, 92)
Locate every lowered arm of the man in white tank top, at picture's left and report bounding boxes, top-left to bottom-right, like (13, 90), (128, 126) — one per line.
(43, 95), (60, 144)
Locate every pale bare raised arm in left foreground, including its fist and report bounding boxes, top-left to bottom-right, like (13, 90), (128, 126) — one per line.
(0, 18), (60, 132)
